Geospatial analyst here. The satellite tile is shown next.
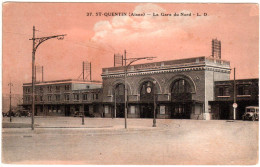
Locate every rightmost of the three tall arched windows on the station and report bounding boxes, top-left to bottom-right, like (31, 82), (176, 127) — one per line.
(170, 78), (192, 119)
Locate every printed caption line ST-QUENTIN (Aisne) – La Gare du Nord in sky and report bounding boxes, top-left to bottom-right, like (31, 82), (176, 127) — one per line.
(86, 12), (207, 17)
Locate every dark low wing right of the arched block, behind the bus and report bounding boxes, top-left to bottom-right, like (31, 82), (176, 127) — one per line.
(209, 79), (259, 120)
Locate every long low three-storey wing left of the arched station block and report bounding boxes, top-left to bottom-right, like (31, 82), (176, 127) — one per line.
(23, 79), (103, 116)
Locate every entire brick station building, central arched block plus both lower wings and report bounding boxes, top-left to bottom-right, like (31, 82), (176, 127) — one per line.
(23, 57), (259, 120)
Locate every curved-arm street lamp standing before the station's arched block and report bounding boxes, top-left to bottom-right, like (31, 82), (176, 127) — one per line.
(123, 50), (155, 129)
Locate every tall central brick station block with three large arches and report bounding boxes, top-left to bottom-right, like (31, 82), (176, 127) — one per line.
(101, 57), (231, 120)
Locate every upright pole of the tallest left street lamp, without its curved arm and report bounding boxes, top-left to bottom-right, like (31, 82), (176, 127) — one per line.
(31, 26), (35, 130)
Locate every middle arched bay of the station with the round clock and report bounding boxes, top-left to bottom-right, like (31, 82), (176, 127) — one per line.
(140, 81), (156, 118)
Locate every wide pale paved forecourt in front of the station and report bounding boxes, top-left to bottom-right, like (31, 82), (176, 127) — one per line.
(2, 117), (258, 165)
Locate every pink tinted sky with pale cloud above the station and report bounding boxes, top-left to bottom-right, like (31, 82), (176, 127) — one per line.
(2, 3), (259, 93)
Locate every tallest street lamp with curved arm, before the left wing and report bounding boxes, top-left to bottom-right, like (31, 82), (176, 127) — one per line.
(29, 26), (66, 130)
